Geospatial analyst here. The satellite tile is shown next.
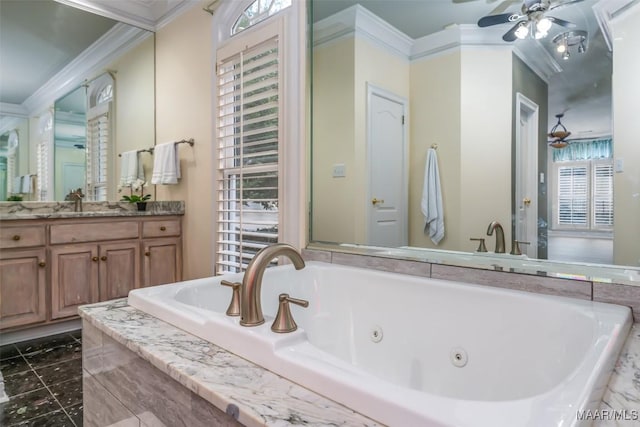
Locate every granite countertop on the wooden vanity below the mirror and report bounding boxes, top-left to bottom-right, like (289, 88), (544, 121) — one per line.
(0, 201), (184, 221)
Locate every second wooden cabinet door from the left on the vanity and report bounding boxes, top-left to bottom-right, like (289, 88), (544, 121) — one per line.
(51, 244), (100, 319)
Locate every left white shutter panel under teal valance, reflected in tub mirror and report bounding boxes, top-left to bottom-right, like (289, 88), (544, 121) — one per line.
(558, 166), (589, 226)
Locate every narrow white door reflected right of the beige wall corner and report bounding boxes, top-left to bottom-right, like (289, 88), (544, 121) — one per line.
(514, 93), (538, 258)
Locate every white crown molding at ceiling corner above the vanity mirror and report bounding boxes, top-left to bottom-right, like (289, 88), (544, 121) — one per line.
(55, 0), (200, 32)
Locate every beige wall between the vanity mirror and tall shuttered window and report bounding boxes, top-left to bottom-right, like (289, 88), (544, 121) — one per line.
(156, 7), (215, 279)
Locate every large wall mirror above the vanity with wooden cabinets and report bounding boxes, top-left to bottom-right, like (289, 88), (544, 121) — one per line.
(0, 0), (155, 201)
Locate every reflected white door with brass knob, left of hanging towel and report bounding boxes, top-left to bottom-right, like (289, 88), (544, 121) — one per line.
(367, 85), (408, 247)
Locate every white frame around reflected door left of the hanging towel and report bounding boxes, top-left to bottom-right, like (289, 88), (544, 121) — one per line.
(364, 82), (409, 244)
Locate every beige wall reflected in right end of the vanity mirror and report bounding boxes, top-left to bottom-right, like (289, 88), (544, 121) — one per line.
(107, 37), (155, 200)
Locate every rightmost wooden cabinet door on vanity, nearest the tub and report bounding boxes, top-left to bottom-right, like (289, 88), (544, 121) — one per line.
(142, 238), (182, 286)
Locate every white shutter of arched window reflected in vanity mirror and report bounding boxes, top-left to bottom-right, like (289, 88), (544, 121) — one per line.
(86, 105), (109, 201)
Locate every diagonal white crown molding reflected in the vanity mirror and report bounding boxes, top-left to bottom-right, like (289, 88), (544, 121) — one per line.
(22, 23), (153, 116)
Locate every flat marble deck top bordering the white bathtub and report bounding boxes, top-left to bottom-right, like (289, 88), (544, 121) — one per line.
(79, 299), (640, 427)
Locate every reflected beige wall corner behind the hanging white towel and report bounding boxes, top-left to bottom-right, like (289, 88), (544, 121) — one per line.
(409, 49), (511, 251)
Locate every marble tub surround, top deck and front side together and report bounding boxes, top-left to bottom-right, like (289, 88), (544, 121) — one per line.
(80, 299), (640, 427)
